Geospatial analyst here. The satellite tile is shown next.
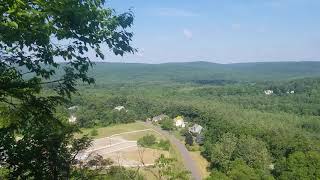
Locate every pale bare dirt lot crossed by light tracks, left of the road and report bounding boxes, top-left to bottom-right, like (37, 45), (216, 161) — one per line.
(77, 129), (168, 167)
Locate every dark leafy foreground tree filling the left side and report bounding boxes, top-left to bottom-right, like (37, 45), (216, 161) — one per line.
(0, 0), (135, 179)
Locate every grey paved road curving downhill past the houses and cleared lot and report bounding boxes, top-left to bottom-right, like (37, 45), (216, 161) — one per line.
(143, 122), (201, 180)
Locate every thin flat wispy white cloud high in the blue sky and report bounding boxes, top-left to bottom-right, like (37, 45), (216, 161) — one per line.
(156, 8), (199, 17)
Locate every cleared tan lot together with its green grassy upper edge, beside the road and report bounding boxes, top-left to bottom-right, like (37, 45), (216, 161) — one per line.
(77, 122), (169, 167)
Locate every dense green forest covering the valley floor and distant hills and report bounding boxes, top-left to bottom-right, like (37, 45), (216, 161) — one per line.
(59, 62), (320, 179)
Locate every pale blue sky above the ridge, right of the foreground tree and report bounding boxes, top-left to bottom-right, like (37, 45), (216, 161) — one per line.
(106, 0), (320, 63)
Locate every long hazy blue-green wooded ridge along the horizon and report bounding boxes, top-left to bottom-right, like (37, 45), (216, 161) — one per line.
(91, 62), (320, 84)
